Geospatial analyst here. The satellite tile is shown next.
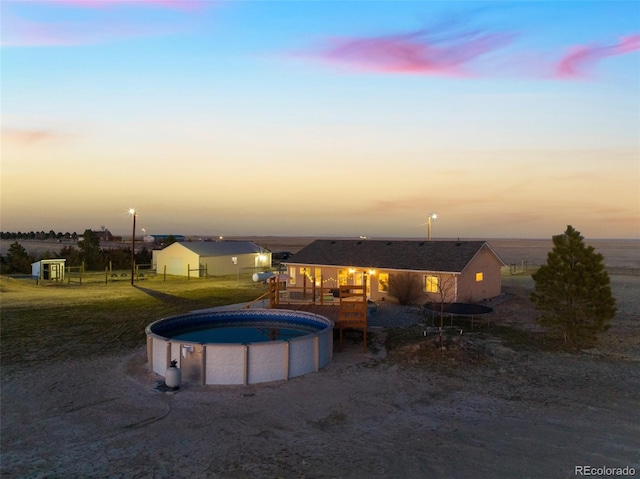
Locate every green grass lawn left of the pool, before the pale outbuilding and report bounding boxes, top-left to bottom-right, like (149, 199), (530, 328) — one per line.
(0, 275), (266, 373)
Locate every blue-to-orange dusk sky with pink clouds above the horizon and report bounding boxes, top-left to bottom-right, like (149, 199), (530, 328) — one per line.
(0, 0), (640, 239)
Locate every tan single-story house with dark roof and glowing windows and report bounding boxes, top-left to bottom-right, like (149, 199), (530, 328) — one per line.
(286, 240), (504, 302)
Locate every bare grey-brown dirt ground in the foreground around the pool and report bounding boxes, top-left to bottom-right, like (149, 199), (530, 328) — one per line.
(1, 277), (640, 478)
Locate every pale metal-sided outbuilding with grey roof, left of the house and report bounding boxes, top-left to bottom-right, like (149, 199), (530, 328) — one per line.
(152, 241), (271, 278)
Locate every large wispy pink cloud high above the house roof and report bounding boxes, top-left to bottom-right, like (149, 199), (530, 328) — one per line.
(317, 30), (513, 76)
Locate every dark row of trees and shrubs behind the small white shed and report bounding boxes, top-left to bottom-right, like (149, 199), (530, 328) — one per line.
(0, 230), (152, 274)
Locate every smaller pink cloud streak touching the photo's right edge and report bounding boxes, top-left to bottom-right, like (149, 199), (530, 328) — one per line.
(555, 35), (640, 79)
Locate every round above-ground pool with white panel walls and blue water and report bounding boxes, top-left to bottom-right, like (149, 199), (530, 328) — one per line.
(145, 309), (333, 384)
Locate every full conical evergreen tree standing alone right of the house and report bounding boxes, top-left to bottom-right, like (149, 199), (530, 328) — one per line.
(530, 225), (616, 347)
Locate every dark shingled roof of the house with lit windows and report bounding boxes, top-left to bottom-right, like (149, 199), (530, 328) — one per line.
(287, 240), (504, 273)
